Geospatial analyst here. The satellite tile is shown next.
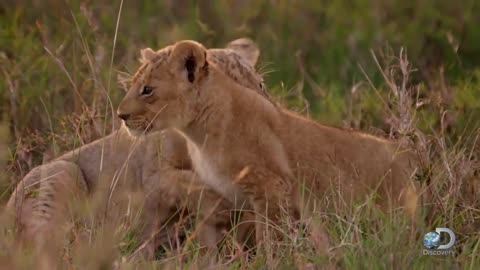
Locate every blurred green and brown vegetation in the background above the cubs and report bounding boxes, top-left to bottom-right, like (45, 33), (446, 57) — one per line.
(0, 0), (480, 198)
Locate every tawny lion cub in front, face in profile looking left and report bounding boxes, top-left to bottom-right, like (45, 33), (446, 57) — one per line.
(118, 41), (417, 250)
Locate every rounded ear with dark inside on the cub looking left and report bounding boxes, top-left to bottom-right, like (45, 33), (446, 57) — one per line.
(169, 40), (208, 83)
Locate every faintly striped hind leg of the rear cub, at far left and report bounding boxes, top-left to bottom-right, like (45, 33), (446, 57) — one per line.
(7, 160), (87, 246)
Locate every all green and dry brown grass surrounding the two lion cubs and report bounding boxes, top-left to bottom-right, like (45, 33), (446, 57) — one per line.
(0, 0), (480, 269)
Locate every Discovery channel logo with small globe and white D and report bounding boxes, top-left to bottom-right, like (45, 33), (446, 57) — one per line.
(423, 228), (455, 256)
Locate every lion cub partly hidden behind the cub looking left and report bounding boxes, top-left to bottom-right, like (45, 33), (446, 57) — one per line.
(2, 39), (266, 257)
